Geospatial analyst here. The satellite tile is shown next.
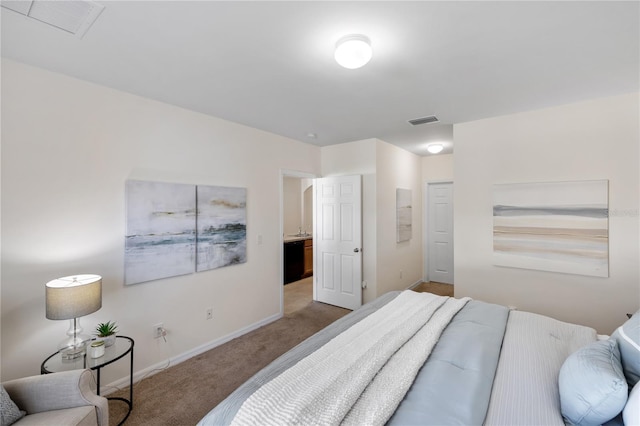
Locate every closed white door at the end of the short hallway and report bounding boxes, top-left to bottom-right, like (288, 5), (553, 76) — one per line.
(424, 182), (454, 285)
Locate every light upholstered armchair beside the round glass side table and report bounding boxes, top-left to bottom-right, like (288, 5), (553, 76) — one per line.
(2, 370), (109, 426)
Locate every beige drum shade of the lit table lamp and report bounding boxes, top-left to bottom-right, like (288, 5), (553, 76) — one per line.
(46, 274), (102, 320)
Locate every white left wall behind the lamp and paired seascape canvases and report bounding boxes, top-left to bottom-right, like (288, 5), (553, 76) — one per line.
(1, 58), (320, 384)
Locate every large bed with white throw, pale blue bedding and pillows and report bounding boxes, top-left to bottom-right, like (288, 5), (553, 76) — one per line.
(199, 290), (640, 426)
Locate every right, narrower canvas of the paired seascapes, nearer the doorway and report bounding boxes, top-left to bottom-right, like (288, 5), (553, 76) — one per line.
(196, 185), (247, 271)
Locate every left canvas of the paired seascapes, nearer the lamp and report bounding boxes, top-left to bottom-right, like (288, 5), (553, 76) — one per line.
(125, 180), (196, 285)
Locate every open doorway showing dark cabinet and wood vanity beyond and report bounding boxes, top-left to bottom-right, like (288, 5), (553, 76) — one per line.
(280, 171), (315, 315)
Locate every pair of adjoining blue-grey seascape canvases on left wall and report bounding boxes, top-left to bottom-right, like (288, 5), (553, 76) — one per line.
(125, 180), (247, 285)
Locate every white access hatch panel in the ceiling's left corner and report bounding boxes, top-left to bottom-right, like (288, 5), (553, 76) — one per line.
(1, 0), (104, 38)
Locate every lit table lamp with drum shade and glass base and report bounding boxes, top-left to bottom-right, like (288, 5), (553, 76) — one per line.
(45, 274), (102, 359)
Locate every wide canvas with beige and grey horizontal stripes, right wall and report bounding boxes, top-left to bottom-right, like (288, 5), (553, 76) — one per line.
(493, 180), (609, 277)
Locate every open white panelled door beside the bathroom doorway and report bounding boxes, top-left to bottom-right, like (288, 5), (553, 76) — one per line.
(313, 176), (362, 309)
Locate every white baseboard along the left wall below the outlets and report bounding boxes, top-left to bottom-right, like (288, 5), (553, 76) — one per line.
(100, 314), (283, 396)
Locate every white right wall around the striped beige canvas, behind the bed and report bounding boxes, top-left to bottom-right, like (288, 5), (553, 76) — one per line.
(454, 94), (640, 334)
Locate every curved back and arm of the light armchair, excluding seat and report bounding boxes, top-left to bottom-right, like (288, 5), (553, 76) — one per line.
(2, 370), (109, 426)
